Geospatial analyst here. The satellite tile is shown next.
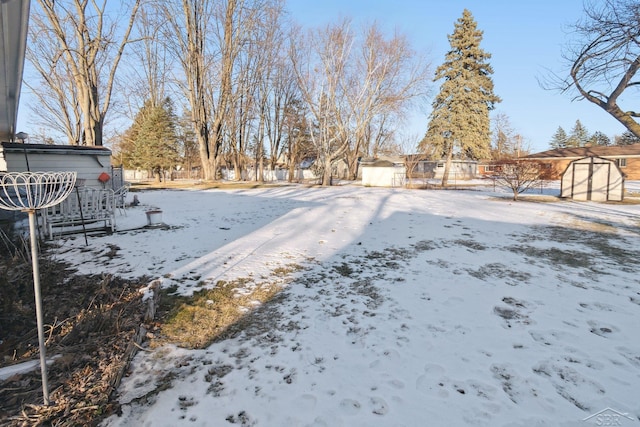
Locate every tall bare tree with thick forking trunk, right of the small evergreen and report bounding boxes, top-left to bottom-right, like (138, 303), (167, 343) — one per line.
(161, 0), (279, 180)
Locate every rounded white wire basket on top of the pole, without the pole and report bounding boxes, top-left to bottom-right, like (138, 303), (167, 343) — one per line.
(0, 172), (77, 210)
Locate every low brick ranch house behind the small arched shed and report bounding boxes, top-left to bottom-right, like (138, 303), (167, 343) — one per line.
(523, 144), (640, 180)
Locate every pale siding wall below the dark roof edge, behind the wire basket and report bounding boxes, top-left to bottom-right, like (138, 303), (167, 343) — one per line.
(0, 149), (111, 188)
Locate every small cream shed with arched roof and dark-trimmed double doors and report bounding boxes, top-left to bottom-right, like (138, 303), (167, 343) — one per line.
(560, 156), (624, 202)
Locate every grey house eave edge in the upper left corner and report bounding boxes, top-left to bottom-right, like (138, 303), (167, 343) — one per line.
(0, 0), (30, 141)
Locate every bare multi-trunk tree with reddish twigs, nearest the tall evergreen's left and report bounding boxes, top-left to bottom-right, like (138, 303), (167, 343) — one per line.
(291, 20), (426, 185)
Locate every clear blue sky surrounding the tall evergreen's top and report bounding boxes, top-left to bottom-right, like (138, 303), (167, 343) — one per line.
(287, 0), (625, 152)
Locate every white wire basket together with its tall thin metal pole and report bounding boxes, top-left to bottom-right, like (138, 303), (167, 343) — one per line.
(0, 172), (76, 405)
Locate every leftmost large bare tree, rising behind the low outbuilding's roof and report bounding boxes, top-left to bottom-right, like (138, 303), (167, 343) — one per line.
(27, 0), (141, 146)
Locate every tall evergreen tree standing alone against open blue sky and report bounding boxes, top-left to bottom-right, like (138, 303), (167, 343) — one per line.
(420, 9), (500, 185)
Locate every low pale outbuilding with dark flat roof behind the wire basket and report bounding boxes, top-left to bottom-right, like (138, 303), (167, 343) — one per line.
(0, 142), (112, 188)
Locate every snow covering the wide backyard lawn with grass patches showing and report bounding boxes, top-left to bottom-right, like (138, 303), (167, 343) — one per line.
(48, 182), (640, 427)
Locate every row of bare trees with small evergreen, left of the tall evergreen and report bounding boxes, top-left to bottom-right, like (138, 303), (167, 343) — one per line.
(28, 0), (430, 184)
